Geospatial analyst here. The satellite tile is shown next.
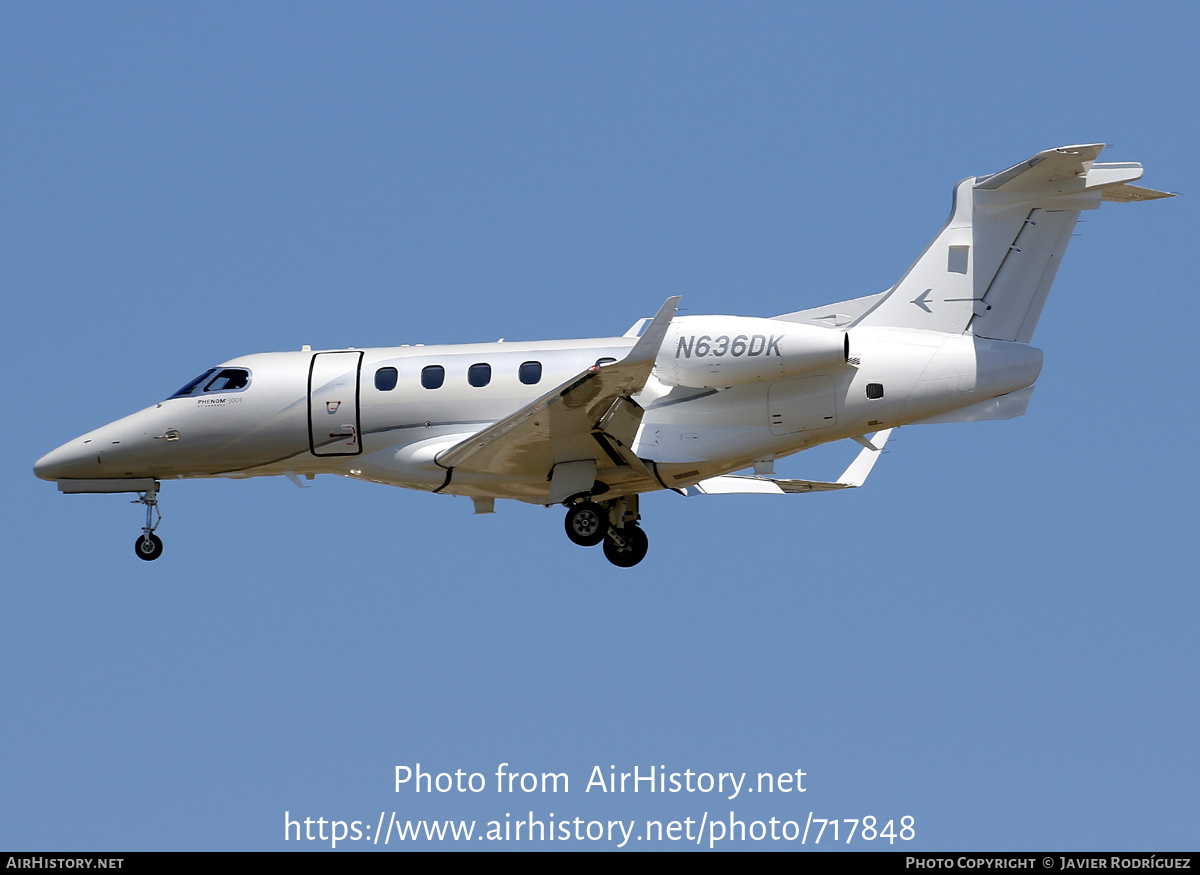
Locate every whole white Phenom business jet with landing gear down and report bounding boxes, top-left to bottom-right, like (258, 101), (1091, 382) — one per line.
(34, 144), (1170, 567)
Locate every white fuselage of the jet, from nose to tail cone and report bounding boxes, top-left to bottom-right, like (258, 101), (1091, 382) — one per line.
(35, 316), (1042, 503)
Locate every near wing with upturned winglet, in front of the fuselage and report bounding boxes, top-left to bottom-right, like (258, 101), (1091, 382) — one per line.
(437, 295), (679, 504)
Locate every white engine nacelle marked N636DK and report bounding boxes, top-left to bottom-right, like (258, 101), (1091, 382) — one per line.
(654, 316), (850, 389)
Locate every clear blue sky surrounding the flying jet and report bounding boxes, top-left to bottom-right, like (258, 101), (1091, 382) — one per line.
(0, 2), (1200, 850)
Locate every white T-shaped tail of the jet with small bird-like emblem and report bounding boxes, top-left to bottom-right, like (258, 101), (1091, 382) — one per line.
(854, 143), (1171, 343)
